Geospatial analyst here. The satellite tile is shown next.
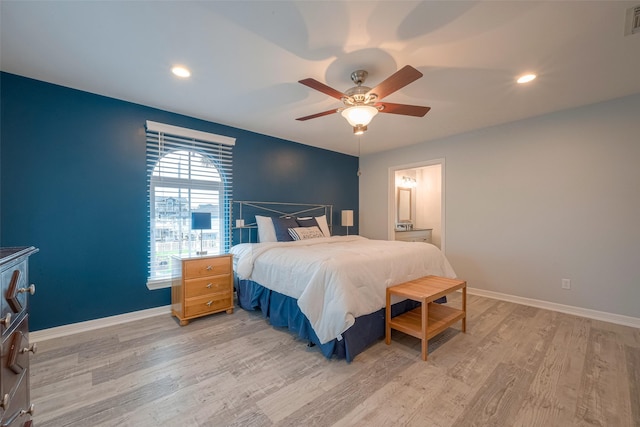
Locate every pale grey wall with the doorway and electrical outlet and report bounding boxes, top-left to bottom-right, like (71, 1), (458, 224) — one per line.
(360, 94), (640, 318)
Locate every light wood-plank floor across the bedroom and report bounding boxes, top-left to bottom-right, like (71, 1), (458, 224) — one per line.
(31, 295), (640, 427)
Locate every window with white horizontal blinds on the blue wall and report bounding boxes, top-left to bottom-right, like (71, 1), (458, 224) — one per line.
(147, 121), (235, 289)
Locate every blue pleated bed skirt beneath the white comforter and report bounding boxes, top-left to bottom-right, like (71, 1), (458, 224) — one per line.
(235, 280), (419, 362)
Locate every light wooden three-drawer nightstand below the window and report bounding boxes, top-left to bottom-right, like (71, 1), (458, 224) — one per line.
(171, 254), (233, 326)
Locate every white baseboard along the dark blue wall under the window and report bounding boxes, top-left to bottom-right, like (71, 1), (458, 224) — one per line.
(29, 305), (171, 342)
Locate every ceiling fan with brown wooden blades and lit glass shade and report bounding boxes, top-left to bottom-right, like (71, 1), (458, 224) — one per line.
(296, 65), (431, 135)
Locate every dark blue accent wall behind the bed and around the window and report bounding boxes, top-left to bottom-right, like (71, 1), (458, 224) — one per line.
(0, 73), (358, 331)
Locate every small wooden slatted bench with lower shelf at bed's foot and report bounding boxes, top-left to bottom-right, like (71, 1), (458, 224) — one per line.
(385, 276), (467, 360)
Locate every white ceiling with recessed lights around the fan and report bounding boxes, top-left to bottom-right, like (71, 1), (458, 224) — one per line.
(0, 0), (640, 155)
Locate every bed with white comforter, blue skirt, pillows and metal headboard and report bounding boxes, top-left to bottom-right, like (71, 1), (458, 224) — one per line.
(230, 202), (455, 362)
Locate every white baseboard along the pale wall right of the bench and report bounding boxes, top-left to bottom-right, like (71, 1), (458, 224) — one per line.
(467, 288), (640, 328)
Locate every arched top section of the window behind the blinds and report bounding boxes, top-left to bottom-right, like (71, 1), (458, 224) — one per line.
(153, 150), (221, 182)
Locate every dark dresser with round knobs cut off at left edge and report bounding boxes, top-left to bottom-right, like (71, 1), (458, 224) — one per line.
(0, 247), (38, 427)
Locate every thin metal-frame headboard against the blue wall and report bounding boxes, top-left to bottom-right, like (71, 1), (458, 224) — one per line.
(231, 200), (333, 243)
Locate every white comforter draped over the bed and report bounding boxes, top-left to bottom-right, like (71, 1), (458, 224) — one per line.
(231, 236), (456, 343)
